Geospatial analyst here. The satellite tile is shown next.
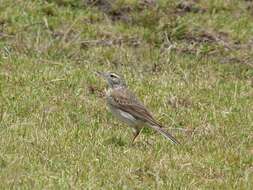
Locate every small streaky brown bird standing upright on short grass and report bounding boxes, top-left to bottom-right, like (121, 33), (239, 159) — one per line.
(97, 72), (180, 144)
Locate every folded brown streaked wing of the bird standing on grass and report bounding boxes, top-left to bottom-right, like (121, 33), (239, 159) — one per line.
(111, 89), (161, 127)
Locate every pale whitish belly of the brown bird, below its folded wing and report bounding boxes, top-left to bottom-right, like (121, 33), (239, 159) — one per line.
(109, 106), (139, 126)
